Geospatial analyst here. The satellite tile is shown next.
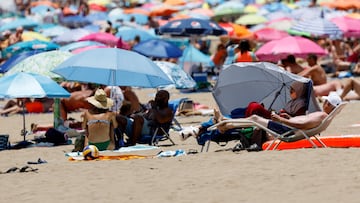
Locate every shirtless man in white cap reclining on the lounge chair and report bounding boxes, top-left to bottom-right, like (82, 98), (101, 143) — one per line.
(218, 93), (341, 134)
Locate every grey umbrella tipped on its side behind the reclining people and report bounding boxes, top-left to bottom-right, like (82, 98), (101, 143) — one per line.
(213, 62), (320, 115)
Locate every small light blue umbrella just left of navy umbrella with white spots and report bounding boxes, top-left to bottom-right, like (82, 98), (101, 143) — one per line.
(115, 26), (158, 41)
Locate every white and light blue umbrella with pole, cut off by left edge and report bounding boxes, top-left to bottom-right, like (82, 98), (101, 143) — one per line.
(0, 72), (70, 142)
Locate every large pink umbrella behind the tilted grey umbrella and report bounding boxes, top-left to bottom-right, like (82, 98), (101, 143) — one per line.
(255, 36), (327, 62)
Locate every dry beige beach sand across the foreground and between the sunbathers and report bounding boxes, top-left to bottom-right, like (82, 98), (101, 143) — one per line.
(0, 89), (360, 202)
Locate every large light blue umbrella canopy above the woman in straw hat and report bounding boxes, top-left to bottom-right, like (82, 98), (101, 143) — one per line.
(53, 48), (173, 87)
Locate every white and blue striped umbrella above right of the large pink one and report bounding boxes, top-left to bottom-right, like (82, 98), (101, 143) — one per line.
(290, 17), (343, 39)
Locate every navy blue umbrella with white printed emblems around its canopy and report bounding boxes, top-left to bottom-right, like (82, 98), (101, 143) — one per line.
(158, 18), (227, 36)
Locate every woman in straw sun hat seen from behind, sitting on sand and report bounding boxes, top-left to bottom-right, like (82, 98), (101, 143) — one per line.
(82, 89), (117, 150)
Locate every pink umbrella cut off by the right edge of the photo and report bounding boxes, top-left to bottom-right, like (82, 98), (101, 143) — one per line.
(330, 17), (360, 37)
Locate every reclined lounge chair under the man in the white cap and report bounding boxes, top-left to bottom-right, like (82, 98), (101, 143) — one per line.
(208, 102), (347, 150)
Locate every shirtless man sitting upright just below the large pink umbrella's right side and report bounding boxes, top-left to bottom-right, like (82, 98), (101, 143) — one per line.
(298, 54), (326, 86)
